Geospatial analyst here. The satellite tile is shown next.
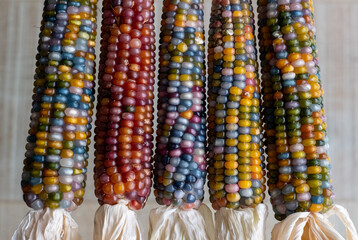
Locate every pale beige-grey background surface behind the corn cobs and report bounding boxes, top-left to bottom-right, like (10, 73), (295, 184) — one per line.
(0, 0), (358, 240)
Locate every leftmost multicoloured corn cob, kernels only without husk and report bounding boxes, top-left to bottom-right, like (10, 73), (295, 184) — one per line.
(22, 0), (96, 211)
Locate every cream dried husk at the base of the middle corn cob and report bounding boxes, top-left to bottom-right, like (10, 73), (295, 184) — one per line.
(149, 206), (214, 240)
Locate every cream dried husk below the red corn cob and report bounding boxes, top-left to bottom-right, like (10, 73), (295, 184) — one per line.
(93, 201), (142, 240)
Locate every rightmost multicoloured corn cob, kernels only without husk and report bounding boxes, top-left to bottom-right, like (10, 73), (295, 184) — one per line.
(259, 0), (332, 220)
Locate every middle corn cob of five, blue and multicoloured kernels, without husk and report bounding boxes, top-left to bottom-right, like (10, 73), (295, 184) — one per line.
(154, 0), (206, 209)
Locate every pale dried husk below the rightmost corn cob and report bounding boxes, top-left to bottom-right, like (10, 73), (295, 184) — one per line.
(271, 205), (358, 240)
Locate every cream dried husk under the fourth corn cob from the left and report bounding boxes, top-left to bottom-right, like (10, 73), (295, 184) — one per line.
(215, 204), (267, 240)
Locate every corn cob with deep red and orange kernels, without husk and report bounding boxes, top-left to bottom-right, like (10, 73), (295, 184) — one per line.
(94, 0), (155, 210)
